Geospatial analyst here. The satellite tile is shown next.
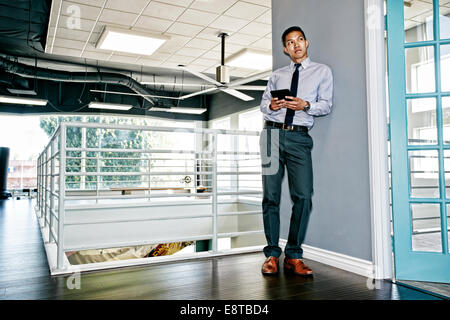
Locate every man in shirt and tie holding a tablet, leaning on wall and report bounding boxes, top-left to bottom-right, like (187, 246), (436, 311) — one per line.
(260, 26), (333, 276)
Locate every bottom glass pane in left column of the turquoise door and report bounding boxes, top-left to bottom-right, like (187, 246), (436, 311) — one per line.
(411, 203), (442, 252)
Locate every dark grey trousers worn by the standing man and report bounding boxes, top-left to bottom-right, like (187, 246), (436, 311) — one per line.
(260, 127), (313, 259)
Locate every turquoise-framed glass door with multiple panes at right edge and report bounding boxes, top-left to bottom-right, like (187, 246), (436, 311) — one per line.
(386, 0), (450, 283)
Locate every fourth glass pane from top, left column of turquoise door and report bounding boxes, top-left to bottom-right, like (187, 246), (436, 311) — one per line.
(408, 150), (439, 198)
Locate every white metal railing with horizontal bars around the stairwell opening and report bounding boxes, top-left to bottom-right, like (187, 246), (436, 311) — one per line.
(36, 122), (263, 270)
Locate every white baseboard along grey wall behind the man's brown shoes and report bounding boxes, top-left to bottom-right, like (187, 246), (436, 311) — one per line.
(279, 239), (374, 278)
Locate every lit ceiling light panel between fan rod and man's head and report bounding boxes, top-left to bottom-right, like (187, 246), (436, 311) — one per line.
(225, 48), (272, 70)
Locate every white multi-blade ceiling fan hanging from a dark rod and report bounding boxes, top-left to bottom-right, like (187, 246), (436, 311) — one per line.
(178, 33), (272, 101)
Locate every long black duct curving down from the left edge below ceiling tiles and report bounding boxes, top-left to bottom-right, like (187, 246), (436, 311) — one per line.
(0, 57), (155, 107)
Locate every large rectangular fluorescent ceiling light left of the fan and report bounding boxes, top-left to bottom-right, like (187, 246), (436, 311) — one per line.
(96, 26), (169, 56)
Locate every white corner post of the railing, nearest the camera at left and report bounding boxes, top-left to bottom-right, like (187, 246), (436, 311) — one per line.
(57, 123), (66, 270)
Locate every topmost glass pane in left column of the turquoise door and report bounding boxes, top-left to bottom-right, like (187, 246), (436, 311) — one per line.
(404, 0), (434, 42)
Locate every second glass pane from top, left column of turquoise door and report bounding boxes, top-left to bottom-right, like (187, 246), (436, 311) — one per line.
(405, 47), (436, 93)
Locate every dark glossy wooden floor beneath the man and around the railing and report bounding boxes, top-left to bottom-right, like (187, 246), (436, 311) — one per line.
(0, 199), (437, 300)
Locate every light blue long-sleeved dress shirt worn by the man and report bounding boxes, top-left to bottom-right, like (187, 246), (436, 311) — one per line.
(260, 58), (333, 129)
